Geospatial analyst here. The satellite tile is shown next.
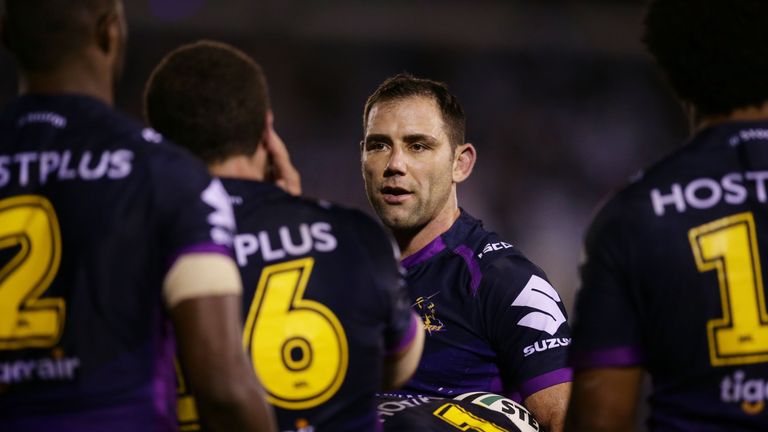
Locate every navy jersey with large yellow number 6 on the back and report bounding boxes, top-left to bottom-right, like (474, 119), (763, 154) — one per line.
(200, 179), (419, 431)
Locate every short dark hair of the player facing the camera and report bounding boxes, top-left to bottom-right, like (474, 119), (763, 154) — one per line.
(363, 73), (466, 146)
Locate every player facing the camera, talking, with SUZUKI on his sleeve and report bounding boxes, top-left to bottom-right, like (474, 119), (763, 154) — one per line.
(361, 74), (571, 430)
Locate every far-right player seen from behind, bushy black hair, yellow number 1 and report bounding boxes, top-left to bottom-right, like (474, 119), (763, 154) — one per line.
(569, 0), (768, 431)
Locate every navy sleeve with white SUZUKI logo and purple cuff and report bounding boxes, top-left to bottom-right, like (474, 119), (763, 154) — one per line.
(478, 256), (572, 399)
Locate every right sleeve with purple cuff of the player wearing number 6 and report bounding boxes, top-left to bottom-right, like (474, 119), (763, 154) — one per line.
(352, 209), (421, 355)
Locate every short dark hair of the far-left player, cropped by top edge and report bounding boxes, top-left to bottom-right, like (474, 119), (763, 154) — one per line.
(2, 0), (119, 72)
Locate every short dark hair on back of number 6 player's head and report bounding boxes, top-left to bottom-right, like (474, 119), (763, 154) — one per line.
(144, 41), (269, 164)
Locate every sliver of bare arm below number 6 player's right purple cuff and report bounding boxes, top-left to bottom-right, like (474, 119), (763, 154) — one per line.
(381, 312), (424, 391)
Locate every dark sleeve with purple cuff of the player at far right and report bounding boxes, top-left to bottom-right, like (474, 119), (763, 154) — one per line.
(570, 196), (645, 368)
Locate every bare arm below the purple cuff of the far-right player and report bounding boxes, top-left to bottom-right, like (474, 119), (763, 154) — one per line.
(566, 367), (643, 432)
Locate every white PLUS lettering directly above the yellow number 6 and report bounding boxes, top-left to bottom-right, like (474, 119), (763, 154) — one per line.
(235, 222), (338, 267)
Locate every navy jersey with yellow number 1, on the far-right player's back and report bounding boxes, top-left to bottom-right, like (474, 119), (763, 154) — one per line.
(572, 123), (768, 431)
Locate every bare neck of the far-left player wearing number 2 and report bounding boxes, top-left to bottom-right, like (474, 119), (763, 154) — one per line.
(19, 56), (114, 106)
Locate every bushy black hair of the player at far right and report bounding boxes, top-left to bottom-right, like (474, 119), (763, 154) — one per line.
(643, 0), (768, 116)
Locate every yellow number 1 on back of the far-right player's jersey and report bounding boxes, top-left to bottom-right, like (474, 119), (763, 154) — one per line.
(688, 213), (768, 366)
